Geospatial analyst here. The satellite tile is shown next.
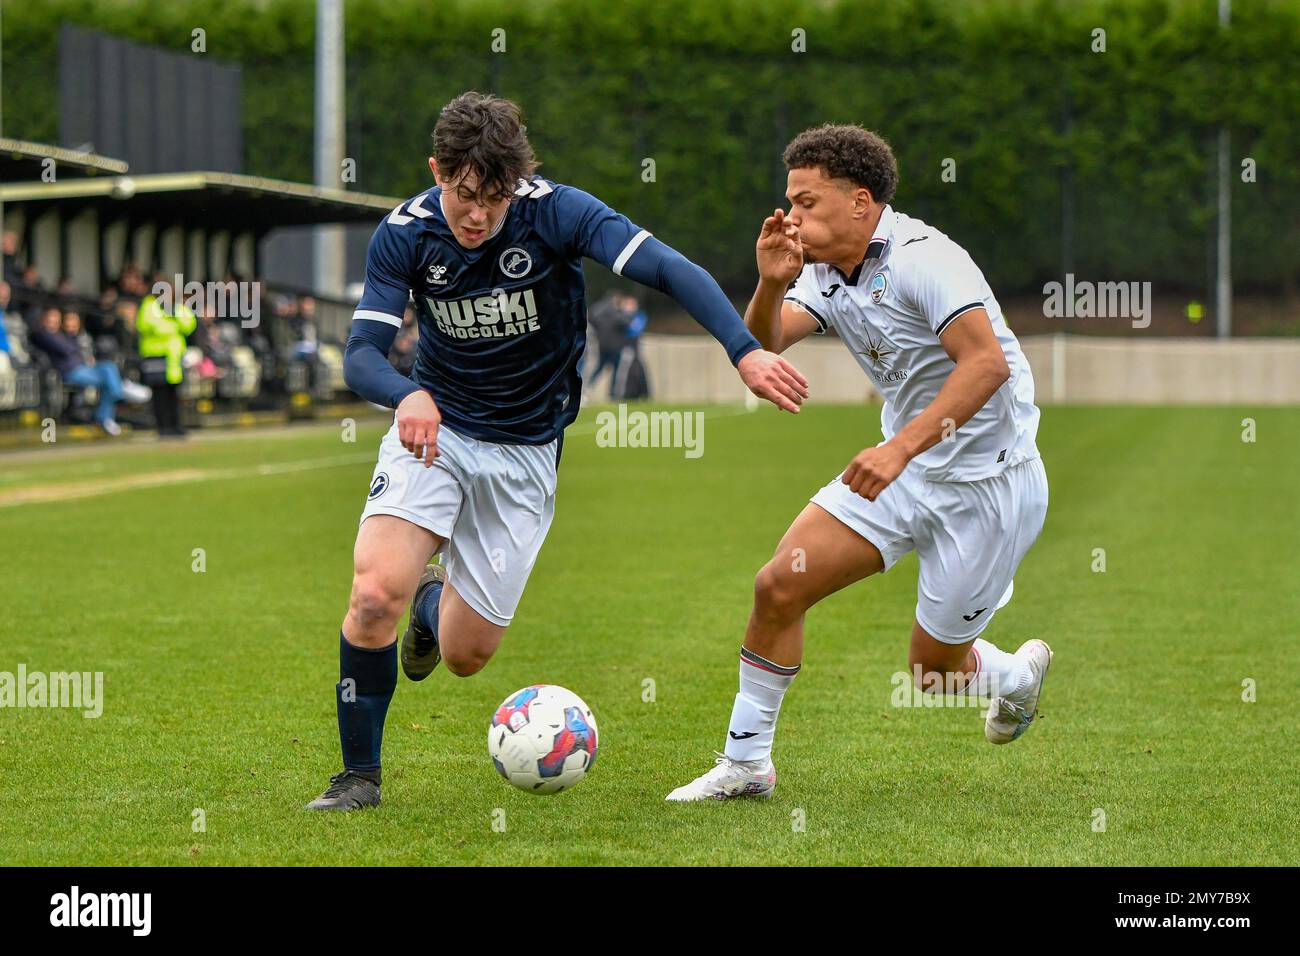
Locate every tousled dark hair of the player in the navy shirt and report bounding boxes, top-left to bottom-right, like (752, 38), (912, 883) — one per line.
(433, 90), (537, 203)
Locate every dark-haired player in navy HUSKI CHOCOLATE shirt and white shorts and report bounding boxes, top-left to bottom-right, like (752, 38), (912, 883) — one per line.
(308, 92), (807, 810)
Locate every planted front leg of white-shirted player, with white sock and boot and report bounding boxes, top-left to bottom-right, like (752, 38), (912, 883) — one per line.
(667, 505), (884, 801)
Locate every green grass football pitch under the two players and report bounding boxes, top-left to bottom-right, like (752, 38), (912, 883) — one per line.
(0, 406), (1300, 865)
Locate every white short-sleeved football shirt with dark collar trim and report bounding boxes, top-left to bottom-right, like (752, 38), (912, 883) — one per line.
(785, 206), (1039, 481)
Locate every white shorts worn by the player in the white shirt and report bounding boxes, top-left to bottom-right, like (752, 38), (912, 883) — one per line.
(811, 458), (1048, 644)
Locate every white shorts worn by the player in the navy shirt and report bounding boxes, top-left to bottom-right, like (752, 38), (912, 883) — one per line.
(361, 421), (558, 627)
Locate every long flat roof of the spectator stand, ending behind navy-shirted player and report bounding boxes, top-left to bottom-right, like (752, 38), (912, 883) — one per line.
(0, 172), (402, 233)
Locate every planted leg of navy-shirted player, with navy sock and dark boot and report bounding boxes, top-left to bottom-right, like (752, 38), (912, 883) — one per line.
(308, 515), (442, 810)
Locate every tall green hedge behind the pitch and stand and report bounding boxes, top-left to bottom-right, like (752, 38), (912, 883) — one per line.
(0, 0), (1300, 294)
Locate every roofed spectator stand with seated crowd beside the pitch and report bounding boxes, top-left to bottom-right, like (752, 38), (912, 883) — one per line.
(0, 166), (398, 442)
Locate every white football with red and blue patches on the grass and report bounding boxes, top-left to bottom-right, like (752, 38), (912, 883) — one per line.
(488, 684), (598, 793)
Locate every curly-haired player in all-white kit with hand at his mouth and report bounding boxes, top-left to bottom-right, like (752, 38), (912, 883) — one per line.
(667, 126), (1052, 801)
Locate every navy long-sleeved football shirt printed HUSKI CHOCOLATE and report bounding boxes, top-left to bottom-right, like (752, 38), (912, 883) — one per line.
(347, 177), (759, 445)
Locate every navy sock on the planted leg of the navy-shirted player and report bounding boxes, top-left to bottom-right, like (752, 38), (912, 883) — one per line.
(334, 631), (398, 777)
